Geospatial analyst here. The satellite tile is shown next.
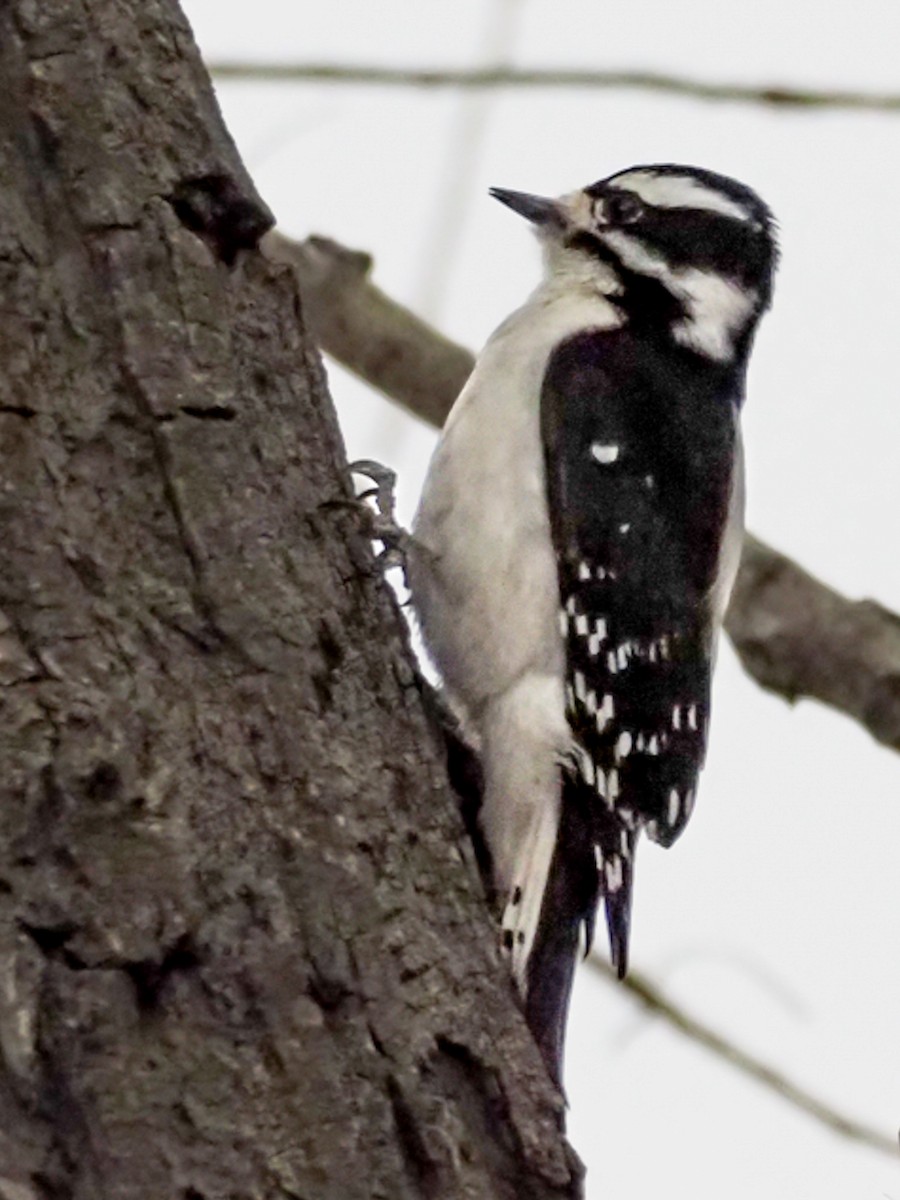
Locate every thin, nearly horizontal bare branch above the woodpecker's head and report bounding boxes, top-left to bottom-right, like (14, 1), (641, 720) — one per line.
(209, 62), (900, 113)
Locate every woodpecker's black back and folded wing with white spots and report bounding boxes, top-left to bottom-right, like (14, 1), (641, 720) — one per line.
(536, 328), (739, 976)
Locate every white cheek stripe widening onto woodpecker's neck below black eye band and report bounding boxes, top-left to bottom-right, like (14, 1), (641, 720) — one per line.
(598, 229), (758, 362)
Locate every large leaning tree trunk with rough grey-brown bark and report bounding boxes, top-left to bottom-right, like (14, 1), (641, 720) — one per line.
(0, 0), (581, 1200)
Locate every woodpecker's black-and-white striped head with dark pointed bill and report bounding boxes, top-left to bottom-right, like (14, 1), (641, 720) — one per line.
(491, 164), (778, 364)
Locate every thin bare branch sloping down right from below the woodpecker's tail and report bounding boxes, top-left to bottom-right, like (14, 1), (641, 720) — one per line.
(588, 954), (898, 1158)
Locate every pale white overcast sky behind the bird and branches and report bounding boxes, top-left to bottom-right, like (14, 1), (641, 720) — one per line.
(177, 0), (900, 1200)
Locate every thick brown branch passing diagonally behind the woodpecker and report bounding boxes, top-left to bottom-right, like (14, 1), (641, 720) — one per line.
(263, 233), (900, 750)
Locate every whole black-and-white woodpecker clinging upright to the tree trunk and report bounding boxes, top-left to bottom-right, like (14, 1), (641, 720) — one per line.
(409, 166), (776, 1081)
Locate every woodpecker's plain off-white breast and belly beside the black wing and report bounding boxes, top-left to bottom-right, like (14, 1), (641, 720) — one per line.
(410, 283), (622, 715)
